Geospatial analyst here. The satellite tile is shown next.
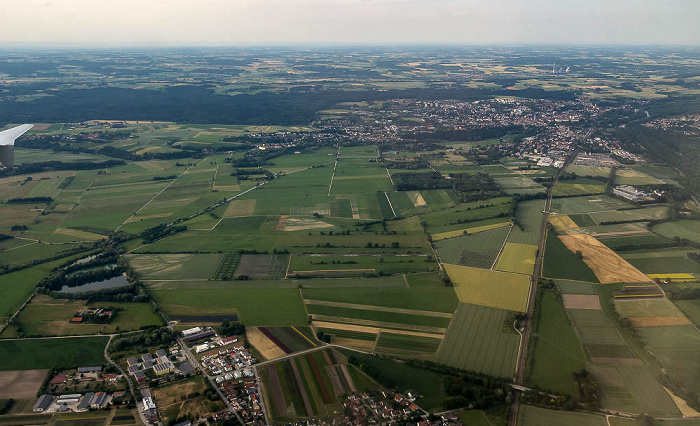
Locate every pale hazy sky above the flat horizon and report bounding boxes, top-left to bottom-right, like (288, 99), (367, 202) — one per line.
(0, 0), (700, 47)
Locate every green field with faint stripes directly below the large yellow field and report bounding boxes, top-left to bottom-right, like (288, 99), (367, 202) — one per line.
(436, 303), (520, 379)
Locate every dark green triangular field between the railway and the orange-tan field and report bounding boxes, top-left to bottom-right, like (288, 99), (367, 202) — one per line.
(542, 232), (599, 283)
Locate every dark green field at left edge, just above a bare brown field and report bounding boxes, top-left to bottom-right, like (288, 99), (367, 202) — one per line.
(0, 337), (108, 371)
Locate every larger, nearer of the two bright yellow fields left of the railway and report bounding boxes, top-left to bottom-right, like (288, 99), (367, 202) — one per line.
(444, 264), (530, 312)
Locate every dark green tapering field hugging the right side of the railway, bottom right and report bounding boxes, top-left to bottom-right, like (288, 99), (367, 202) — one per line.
(528, 291), (586, 395)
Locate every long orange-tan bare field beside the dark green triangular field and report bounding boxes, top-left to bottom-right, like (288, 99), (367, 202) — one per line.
(559, 234), (650, 284)
